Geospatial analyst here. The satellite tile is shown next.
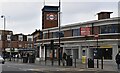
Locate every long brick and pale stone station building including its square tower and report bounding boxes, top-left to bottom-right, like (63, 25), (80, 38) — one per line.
(36, 6), (120, 61)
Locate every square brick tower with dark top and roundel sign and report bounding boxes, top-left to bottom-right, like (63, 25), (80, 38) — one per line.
(42, 6), (59, 29)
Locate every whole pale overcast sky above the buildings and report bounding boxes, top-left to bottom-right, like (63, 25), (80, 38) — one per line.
(0, 0), (119, 35)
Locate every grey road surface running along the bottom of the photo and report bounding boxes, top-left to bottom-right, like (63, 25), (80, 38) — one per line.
(2, 62), (119, 73)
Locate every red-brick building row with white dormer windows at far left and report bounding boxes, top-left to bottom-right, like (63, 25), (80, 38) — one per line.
(0, 30), (34, 52)
